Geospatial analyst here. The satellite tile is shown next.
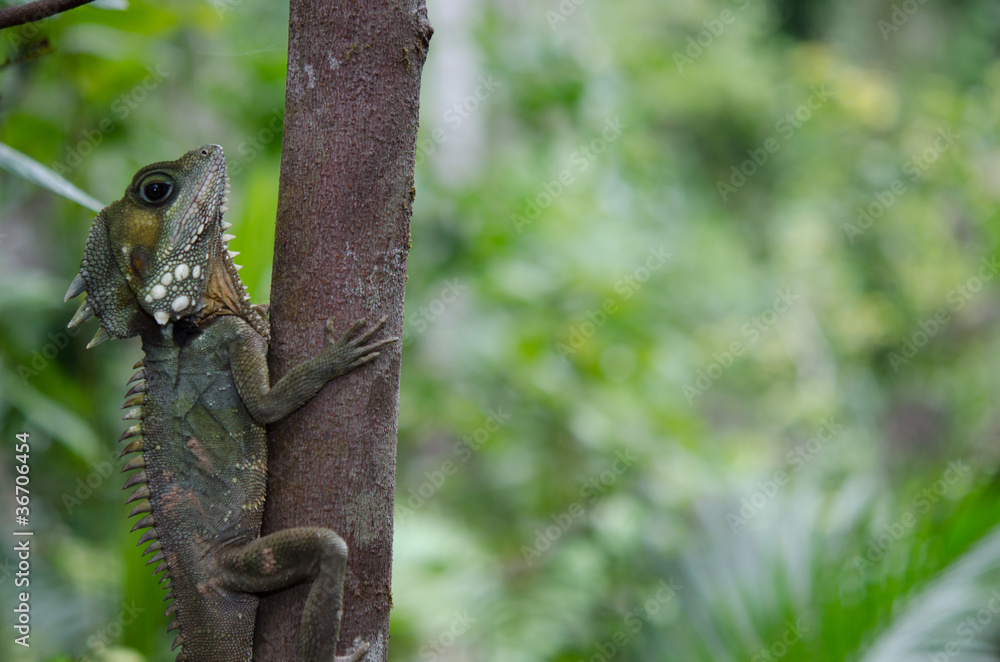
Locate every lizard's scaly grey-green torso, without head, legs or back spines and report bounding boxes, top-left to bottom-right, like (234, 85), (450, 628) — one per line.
(142, 317), (267, 660)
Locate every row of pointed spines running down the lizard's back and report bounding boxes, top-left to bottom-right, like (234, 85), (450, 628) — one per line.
(118, 360), (184, 660)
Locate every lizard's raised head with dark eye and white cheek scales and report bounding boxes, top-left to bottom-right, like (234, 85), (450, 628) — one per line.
(66, 145), (249, 346)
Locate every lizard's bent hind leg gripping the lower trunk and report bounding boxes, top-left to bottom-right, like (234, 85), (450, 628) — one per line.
(220, 527), (368, 662)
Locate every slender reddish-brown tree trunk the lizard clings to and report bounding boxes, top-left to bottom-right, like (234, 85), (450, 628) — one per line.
(254, 0), (432, 662)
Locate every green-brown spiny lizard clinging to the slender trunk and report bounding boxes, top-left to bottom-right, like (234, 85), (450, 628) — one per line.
(65, 145), (398, 662)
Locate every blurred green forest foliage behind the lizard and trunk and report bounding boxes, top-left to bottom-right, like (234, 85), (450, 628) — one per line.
(0, 0), (1000, 662)
